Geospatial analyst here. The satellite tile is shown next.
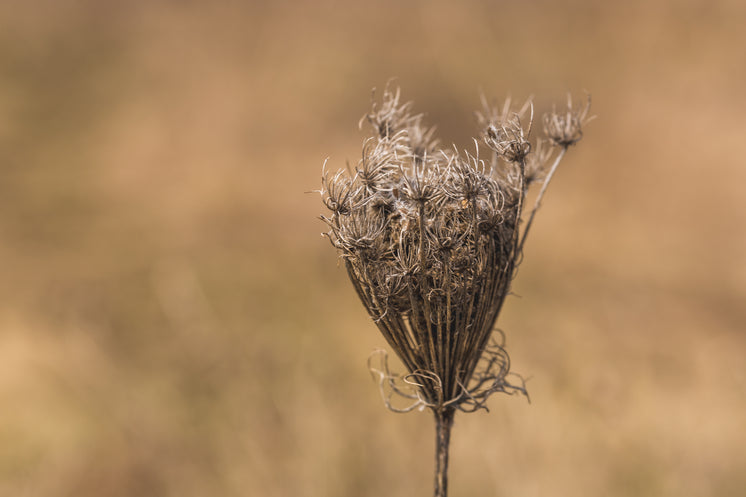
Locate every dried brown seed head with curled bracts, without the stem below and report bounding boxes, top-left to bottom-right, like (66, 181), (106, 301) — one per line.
(321, 87), (587, 411)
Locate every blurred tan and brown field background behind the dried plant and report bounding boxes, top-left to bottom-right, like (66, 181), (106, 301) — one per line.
(0, 0), (746, 497)
